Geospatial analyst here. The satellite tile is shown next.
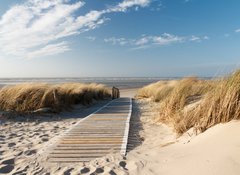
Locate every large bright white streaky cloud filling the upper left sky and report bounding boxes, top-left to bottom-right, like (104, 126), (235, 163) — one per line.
(0, 0), (150, 58)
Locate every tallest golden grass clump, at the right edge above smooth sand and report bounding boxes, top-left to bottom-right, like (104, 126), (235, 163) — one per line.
(187, 70), (240, 131)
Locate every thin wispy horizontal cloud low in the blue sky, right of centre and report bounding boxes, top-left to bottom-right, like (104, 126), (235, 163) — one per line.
(104, 33), (209, 49)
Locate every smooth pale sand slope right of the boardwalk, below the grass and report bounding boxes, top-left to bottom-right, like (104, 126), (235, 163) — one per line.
(127, 100), (240, 175)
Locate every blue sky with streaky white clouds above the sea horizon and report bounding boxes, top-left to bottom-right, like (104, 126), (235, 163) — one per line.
(0, 0), (240, 77)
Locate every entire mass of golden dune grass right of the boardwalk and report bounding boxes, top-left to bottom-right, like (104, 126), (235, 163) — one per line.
(137, 70), (240, 134)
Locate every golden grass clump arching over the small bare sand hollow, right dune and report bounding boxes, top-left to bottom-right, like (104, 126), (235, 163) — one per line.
(156, 77), (213, 133)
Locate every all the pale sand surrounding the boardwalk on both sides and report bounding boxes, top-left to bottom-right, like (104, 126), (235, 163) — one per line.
(0, 90), (240, 175)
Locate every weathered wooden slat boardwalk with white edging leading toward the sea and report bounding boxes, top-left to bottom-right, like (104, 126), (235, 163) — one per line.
(48, 98), (132, 163)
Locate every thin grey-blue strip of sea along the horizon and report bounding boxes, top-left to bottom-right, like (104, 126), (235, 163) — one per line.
(0, 77), (177, 89)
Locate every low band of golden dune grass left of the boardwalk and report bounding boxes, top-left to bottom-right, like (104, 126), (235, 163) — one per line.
(0, 83), (110, 113)
